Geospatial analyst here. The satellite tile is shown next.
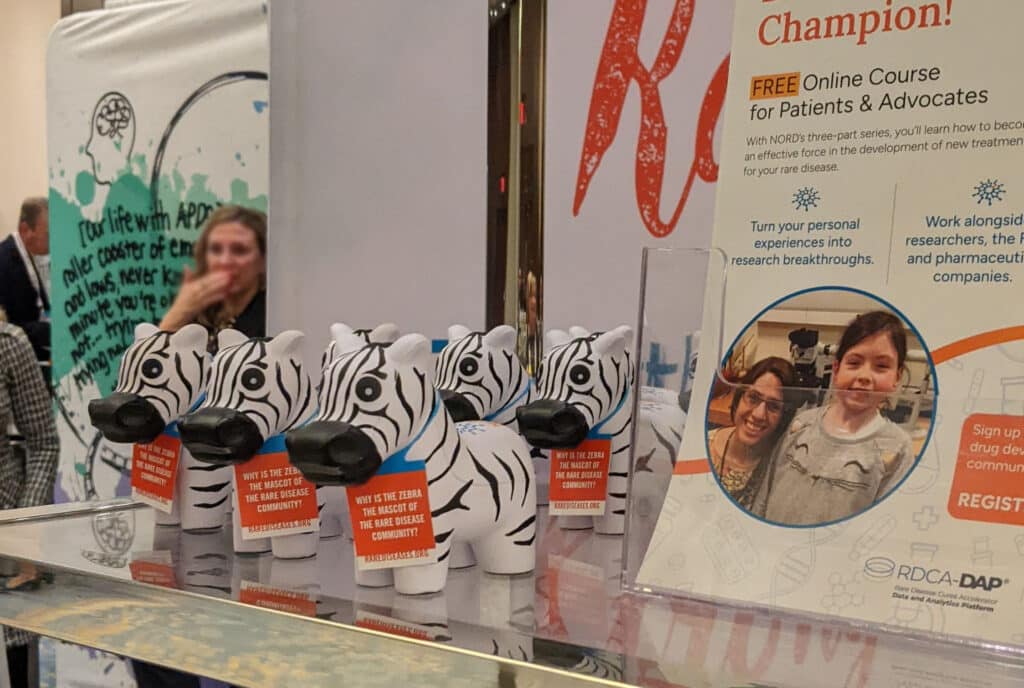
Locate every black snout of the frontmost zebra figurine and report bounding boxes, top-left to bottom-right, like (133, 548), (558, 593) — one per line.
(285, 421), (383, 485)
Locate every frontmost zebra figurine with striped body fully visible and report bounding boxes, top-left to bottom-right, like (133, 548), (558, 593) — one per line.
(286, 333), (537, 595)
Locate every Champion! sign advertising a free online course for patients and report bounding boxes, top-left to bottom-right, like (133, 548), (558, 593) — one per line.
(638, 0), (1024, 645)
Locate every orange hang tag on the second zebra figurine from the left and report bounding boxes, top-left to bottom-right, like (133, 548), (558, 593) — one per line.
(234, 435), (319, 540)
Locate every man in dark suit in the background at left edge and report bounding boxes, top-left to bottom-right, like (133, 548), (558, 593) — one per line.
(0, 197), (50, 371)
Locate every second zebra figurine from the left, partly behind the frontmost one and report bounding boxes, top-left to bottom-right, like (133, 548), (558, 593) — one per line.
(178, 330), (318, 559)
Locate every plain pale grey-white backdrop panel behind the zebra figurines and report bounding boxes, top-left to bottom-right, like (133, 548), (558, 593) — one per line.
(267, 0), (487, 362)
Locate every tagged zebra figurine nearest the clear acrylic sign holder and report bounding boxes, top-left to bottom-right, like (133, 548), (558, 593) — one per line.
(516, 326), (633, 535)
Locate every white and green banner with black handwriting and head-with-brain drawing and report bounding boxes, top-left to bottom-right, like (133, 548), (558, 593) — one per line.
(47, 0), (268, 502)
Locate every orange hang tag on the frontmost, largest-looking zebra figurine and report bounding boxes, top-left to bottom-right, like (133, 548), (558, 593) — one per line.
(345, 466), (435, 571)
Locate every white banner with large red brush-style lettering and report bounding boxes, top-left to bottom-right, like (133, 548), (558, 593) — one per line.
(543, 0), (732, 391)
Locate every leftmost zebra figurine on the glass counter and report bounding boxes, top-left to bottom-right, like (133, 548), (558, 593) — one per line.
(89, 323), (231, 530)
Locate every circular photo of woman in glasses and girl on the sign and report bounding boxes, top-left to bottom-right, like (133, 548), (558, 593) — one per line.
(707, 287), (938, 527)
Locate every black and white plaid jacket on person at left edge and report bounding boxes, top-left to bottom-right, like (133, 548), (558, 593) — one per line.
(0, 323), (59, 645)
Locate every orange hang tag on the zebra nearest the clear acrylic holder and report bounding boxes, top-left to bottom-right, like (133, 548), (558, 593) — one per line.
(548, 438), (611, 516)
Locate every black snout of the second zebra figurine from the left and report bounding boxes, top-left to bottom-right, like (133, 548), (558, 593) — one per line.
(178, 407), (264, 466)
